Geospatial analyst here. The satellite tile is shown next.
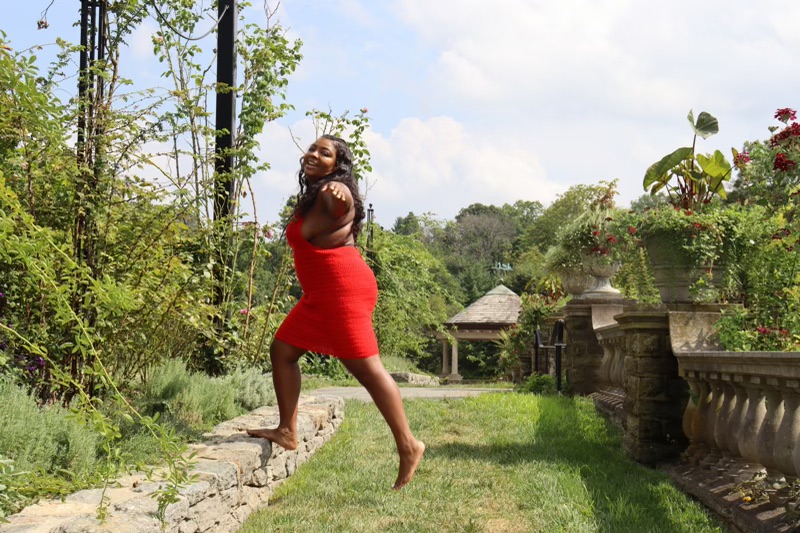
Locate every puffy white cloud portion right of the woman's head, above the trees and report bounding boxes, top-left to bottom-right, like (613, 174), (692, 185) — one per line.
(367, 117), (559, 226)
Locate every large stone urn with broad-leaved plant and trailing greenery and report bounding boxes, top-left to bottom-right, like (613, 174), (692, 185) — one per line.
(637, 111), (747, 303)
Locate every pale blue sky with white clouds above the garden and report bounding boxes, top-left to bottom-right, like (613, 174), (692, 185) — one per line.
(0, 0), (800, 227)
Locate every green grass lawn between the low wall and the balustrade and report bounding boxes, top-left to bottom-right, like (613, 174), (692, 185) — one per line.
(241, 394), (725, 533)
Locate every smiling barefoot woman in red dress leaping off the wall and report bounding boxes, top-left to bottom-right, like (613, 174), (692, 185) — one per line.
(247, 135), (425, 489)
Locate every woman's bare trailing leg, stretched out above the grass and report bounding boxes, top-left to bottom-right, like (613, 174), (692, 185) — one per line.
(340, 355), (425, 489)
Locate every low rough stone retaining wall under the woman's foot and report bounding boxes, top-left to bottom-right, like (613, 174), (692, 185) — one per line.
(0, 396), (344, 533)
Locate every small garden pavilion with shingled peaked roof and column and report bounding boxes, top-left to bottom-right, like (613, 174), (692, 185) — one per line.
(436, 285), (521, 381)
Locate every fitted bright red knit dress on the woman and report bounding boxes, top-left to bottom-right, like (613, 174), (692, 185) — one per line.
(275, 217), (378, 359)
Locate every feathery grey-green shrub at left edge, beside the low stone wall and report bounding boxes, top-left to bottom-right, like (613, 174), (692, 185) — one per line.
(0, 380), (98, 476)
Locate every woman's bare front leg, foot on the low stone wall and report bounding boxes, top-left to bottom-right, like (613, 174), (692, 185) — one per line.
(247, 339), (305, 450)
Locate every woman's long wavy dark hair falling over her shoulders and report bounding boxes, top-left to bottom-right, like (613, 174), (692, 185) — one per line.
(290, 134), (364, 239)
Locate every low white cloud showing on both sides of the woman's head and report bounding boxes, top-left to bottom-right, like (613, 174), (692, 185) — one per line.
(247, 117), (562, 227)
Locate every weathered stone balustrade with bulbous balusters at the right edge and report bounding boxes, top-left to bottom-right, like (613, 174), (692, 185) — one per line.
(676, 352), (800, 476)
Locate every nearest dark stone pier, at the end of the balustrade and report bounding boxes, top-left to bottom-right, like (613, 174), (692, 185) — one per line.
(616, 304), (696, 464)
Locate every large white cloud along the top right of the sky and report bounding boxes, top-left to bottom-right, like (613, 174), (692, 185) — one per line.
(398, 0), (800, 116)
